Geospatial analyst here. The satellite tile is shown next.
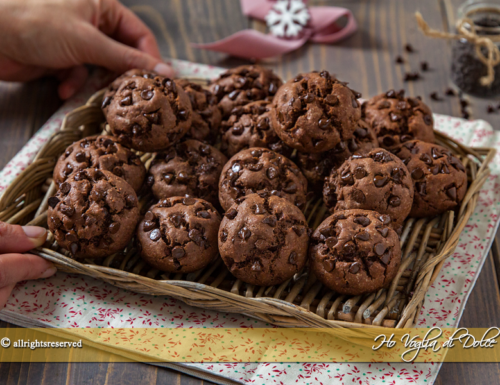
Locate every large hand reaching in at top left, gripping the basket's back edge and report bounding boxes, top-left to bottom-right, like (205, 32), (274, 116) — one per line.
(0, 0), (173, 99)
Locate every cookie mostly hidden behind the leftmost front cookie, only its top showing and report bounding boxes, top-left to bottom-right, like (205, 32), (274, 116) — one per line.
(54, 135), (146, 192)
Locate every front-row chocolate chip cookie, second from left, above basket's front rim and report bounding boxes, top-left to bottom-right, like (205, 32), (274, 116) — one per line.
(137, 197), (221, 273)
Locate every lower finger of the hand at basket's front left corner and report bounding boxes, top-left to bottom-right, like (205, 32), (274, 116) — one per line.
(0, 254), (57, 288)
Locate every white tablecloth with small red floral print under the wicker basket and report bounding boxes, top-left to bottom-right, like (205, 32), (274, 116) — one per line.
(0, 61), (500, 385)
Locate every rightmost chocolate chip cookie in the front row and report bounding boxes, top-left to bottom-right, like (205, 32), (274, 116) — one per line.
(309, 210), (401, 295)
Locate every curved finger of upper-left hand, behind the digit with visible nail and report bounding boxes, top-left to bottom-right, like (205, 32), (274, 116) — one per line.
(99, 0), (161, 60)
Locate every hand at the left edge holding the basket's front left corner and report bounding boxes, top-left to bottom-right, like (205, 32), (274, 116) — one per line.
(0, 222), (57, 309)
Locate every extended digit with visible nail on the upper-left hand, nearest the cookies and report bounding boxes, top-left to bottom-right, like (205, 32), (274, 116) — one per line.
(83, 29), (174, 77)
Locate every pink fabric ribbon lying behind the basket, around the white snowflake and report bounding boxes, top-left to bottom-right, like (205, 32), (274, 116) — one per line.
(193, 0), (358, 59)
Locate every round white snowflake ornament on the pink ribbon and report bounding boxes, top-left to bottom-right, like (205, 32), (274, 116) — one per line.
(266, 0), (311, 37)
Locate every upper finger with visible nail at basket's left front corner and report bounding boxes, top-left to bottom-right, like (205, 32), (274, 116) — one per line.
(0, 222), (47, 254)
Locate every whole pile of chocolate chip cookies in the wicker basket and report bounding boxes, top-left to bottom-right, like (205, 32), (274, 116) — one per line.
(48, 65), (467, 295)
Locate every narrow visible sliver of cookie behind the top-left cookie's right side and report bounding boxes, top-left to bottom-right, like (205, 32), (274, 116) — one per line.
(175, 79), (222, 145)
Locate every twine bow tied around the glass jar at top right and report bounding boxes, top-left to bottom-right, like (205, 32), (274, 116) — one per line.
(415, 12), (500, 86)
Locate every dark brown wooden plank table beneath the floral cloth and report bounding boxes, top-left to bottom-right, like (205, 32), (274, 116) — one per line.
(0, 0), (500, 385)
